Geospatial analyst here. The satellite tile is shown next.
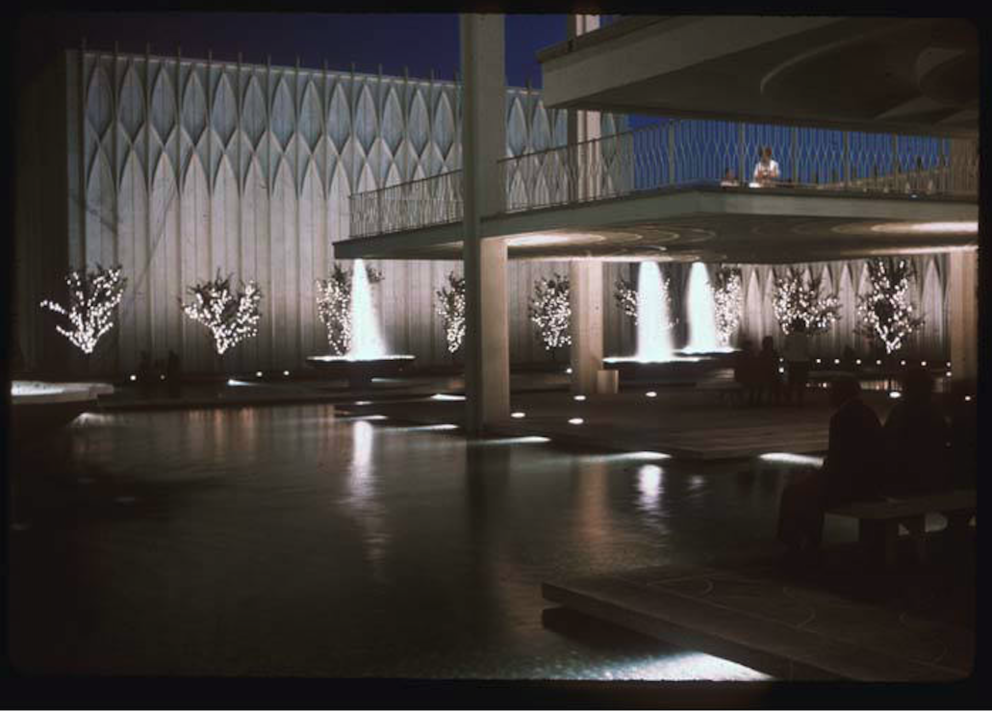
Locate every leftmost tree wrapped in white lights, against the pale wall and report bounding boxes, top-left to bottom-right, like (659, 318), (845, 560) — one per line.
(41, 264), (127, 354)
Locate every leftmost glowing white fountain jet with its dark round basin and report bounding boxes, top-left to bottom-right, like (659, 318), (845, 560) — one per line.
(307, 259), (414, 389)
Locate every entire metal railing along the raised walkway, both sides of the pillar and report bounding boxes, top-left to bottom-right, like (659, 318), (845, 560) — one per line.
(351, 120), (978, 237)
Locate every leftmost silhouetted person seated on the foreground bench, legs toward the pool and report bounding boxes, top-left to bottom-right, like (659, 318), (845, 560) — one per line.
(778, 376), (884, 562)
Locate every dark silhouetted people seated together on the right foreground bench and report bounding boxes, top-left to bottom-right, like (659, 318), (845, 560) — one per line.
(778, 368), (975, 562)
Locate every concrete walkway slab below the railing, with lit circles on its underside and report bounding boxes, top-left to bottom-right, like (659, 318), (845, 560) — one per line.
(334, 187), (978, 264)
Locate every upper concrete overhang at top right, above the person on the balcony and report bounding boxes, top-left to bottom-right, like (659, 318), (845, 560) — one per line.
(538, 16), (979, 137)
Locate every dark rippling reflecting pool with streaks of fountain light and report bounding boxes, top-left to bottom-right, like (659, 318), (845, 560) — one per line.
(9, 405), (800, 679)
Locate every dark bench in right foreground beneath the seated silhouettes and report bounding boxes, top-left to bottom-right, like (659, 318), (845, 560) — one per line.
(826, 489), (976, 566)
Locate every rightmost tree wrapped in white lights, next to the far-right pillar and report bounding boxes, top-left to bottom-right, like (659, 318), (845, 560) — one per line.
(856, 259), (923, 355)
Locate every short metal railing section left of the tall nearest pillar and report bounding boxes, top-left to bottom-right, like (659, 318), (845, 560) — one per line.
(349, 170), (463, 237)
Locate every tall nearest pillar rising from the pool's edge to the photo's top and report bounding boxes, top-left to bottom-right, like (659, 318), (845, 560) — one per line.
(460, 14), (510, 434)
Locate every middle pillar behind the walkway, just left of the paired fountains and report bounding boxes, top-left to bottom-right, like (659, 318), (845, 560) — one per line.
(566, 15), (611, 394)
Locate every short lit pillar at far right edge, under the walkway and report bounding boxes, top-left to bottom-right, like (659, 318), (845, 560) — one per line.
(947, 251), (978, 394)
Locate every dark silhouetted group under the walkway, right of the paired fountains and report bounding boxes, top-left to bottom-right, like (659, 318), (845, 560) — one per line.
(734, 318), (809, 406)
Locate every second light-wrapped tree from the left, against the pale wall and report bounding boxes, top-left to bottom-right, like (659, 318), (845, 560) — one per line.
(180, 269), (262, 356)
